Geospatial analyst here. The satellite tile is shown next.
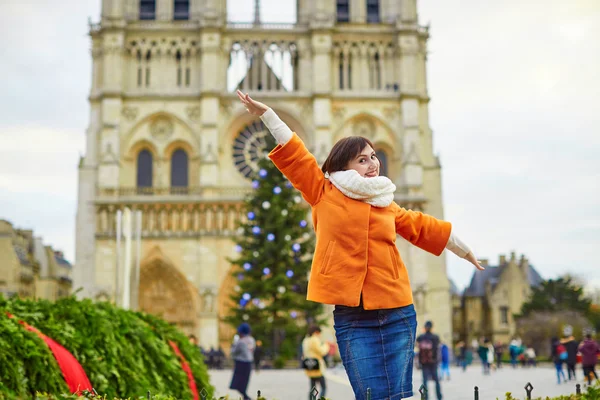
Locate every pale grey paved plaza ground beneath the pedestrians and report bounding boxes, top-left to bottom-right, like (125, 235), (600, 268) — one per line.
(210, 365), (583, 400)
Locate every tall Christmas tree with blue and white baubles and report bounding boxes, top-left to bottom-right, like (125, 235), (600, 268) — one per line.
(225, 138), (322, 362)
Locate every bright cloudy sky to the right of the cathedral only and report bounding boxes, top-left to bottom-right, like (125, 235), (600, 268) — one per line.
(419, 0), (600, 286)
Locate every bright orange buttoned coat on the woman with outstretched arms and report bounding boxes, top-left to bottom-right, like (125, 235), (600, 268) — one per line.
(269, 134), (452, 310)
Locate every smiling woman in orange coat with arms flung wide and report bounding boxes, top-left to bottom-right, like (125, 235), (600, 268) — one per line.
(238, 91), (483, 400)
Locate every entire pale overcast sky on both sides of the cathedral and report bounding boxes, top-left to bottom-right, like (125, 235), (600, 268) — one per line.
(0, 0), (600, 286)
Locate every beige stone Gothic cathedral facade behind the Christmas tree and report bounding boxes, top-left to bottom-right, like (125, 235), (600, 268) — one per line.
(74, 0), (452, 347)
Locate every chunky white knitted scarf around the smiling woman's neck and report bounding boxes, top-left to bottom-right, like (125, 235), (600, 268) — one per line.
(325, 169), (396, 208)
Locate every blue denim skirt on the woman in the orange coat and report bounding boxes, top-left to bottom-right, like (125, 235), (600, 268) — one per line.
(333, 304), (417, 400)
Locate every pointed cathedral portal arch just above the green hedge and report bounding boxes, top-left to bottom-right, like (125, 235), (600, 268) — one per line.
(139, 258), (197, 334)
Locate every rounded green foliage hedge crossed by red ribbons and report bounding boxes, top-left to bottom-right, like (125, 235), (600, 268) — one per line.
(0, 296), (214, 399)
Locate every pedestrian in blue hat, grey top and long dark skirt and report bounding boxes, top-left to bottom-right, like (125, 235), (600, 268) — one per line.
(229, 322), (256, 400)
